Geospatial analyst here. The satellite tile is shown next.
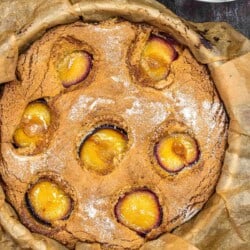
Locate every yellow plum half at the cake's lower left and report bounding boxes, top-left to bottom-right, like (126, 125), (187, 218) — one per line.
(26, 180), (72, 224)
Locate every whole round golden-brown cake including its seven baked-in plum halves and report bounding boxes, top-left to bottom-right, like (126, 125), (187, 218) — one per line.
(1, 19), (227, 249)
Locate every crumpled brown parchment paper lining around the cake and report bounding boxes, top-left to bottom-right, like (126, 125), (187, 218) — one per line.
(0, 0), (250, 250)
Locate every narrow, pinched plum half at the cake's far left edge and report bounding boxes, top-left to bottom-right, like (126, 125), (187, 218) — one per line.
(13, 102), (51, 148)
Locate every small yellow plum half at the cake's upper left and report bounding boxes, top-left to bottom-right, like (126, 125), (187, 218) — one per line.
(57, 51), (92, 88)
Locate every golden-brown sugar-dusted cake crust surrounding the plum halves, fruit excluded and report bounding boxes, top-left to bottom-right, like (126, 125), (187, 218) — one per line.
(0, 20), (227, 249)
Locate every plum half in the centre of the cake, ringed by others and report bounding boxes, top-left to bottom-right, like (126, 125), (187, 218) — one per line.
(79, 126), (128, 174)
